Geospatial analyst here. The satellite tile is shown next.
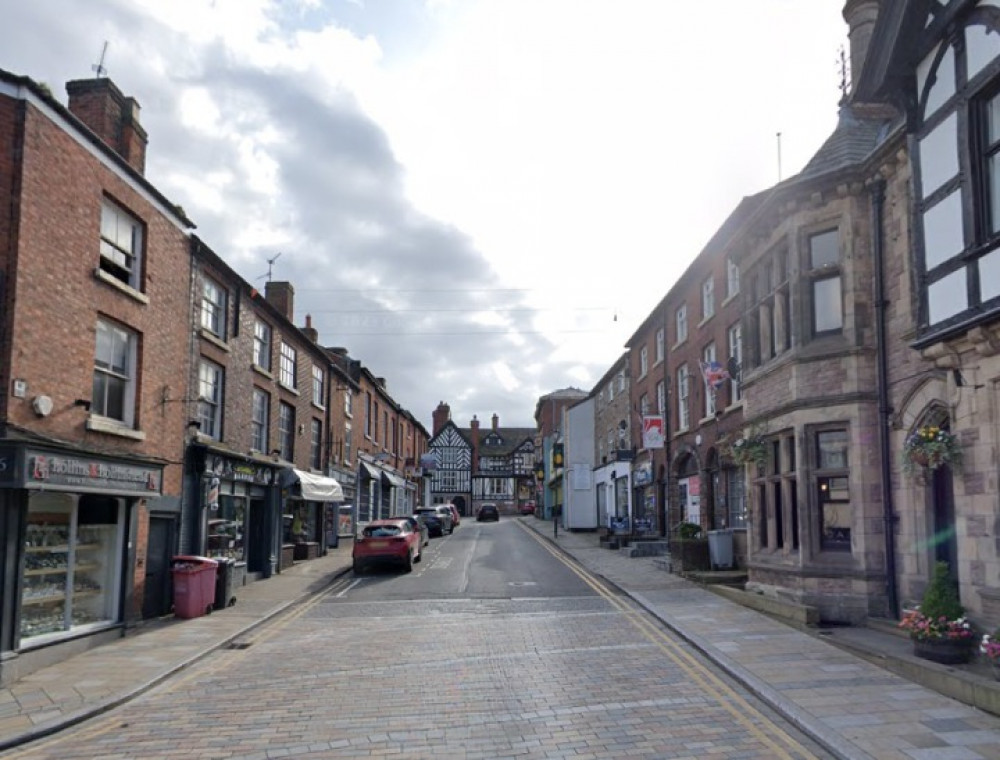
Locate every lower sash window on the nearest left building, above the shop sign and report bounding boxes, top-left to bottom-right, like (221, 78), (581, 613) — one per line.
(91, 319), (139, 427)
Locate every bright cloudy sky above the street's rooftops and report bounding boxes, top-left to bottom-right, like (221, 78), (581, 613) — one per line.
(0, 0), (848, 431)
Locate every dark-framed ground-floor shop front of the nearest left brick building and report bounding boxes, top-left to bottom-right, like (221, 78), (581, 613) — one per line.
(0, 444), (163, 682)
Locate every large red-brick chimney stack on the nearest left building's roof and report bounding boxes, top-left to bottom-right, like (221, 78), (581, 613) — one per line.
(66, 77), (149, 174)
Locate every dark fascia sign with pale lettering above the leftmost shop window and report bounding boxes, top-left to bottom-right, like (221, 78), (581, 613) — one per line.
(25, 452), (162, 494)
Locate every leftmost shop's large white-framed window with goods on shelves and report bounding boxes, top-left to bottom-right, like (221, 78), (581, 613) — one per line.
(20, 493), (124, 640)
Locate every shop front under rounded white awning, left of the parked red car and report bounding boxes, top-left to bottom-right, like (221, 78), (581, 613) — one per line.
(281, 467), (344, 566)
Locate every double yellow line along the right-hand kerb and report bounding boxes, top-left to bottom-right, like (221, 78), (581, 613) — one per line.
(518, 522), (815, 760)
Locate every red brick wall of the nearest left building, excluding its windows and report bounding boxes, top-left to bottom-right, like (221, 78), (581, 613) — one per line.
(0, 95), (190, 617)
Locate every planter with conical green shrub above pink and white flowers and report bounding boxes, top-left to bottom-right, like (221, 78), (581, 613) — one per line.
(899, 562), (975, 665)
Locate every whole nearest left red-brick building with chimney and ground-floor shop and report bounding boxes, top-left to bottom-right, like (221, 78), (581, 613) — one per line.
(0, 71), (192, 680)
